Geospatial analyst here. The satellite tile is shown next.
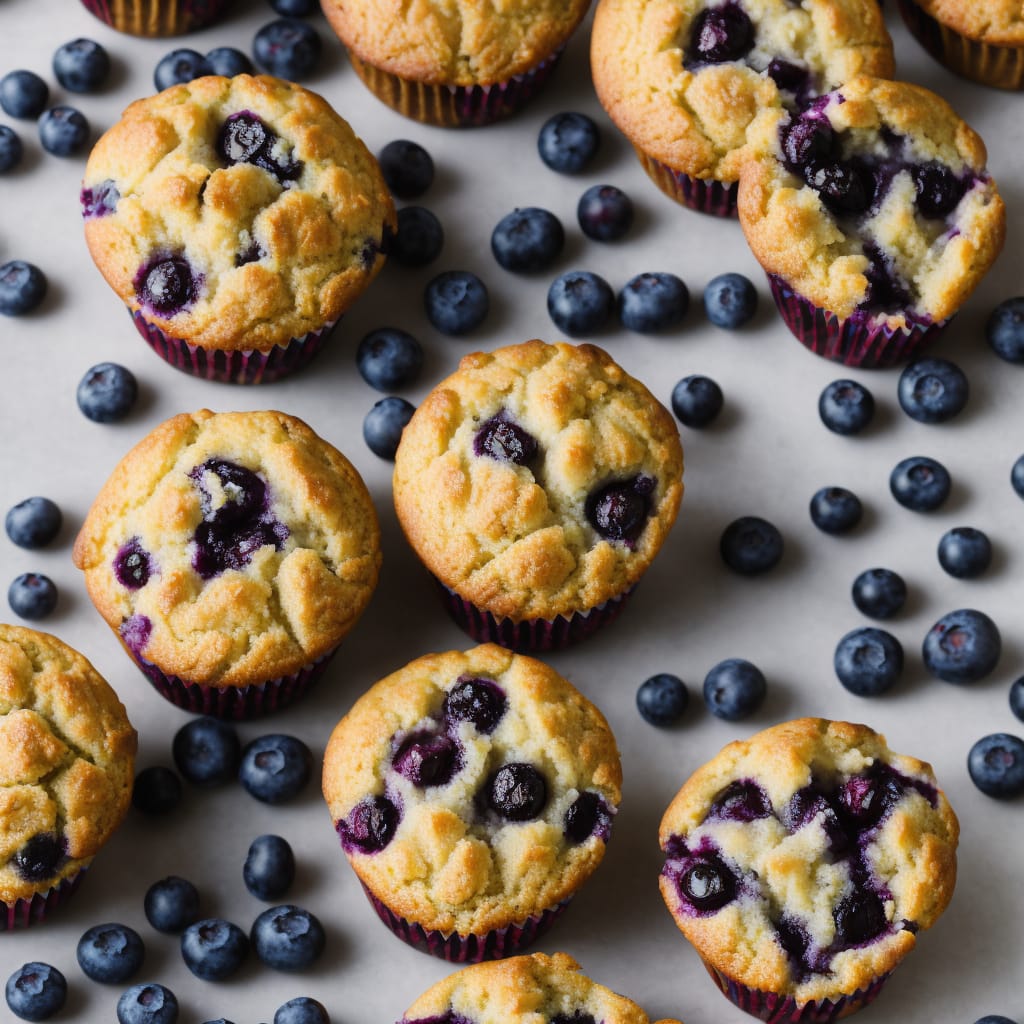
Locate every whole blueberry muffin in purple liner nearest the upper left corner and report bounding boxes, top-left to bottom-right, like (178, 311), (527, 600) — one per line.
(82, 75), (394, 383)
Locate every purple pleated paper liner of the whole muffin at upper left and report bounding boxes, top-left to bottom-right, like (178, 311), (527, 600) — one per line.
(131, 309), (338, 384)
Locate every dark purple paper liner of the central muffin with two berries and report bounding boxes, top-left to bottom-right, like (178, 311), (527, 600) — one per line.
(434, 578), (636, 653)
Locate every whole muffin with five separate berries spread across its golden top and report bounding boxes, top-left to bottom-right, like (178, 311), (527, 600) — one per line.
(324, 644), (622, 962)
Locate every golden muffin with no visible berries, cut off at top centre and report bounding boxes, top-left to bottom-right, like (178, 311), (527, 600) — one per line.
(321, 0), (590, 128)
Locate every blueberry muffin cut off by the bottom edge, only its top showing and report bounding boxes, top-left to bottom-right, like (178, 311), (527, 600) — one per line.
(397, 953), (679, 1024)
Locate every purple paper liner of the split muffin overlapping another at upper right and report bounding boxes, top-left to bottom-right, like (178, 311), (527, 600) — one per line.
(768, 273), (951, 370)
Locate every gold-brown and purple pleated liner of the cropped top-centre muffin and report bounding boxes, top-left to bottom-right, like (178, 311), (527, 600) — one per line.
(348, 48), (562, 128)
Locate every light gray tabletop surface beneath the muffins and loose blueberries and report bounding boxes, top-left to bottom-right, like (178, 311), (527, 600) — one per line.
(0, 6), (1024, 1024)
